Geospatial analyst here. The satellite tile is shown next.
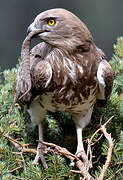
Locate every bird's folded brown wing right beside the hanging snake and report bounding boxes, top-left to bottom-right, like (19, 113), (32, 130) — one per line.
(30, 43), (52, 96)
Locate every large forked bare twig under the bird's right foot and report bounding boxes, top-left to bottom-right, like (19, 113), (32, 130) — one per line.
(42, 116), (114, 180)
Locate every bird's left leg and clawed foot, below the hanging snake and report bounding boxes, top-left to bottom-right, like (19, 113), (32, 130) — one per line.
(33, 122), (48, 168)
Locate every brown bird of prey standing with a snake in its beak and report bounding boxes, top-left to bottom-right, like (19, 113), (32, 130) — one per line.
(16, 8), (113, 166)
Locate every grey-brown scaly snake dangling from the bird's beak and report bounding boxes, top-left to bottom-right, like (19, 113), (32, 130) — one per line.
(16, 30), (43, 105)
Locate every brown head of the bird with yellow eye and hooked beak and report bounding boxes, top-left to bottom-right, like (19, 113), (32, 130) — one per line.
(28, 9), (91, 50)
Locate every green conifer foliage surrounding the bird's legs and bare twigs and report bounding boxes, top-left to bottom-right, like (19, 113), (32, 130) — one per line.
(0, 37), (123, 180)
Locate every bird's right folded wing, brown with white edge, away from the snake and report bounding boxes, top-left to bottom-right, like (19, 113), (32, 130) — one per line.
(97, 57), (114, 105)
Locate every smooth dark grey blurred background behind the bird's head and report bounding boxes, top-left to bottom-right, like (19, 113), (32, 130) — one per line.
(0, 0), (123, 70)
